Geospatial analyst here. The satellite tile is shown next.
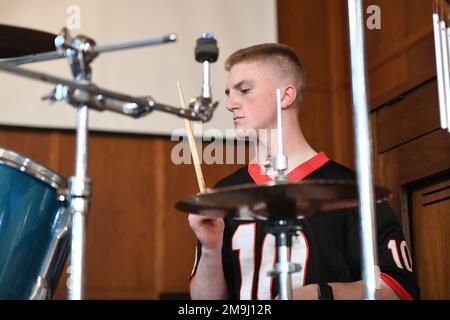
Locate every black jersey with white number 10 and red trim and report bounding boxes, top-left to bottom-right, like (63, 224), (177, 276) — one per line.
(192, 153), (418, 299)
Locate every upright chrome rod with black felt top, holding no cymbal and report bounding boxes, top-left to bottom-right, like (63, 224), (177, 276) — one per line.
(189, 32), (219, 121)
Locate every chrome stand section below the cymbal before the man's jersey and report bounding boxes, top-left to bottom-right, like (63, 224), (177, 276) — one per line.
(268, 219), (302, 300)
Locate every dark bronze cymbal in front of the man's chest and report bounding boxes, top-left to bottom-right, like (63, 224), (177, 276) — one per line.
(175, 180), (390, 219)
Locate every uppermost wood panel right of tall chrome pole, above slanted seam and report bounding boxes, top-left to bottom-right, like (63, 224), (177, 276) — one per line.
(364, 0), (436, 108)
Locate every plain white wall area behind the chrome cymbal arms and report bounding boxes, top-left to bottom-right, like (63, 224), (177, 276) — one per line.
(0, 0), (277, 135)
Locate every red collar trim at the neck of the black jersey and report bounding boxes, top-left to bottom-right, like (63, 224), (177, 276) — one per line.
(248, 152), (330, 184)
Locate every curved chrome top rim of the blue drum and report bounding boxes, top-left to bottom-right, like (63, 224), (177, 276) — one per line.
(0, 147), (67, 190)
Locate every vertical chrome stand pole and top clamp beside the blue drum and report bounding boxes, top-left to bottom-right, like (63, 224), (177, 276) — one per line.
(55, 29), (98, 300)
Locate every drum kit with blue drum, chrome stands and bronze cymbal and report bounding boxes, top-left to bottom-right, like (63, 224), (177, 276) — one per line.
(0, 1), (389, 300)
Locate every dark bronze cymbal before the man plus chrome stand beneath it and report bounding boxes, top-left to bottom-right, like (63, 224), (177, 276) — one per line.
(175, 179), (390, 300)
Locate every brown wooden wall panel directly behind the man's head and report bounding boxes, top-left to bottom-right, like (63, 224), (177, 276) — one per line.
(278, 0), (354, 168)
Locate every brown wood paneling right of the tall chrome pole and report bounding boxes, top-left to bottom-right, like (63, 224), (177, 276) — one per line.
(365, 0), (450, 299)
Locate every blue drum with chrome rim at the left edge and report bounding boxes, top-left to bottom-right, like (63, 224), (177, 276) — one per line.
(0, 148), (70, 299)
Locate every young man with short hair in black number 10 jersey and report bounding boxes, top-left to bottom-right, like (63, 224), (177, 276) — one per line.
(189, 44), (418, 299)
